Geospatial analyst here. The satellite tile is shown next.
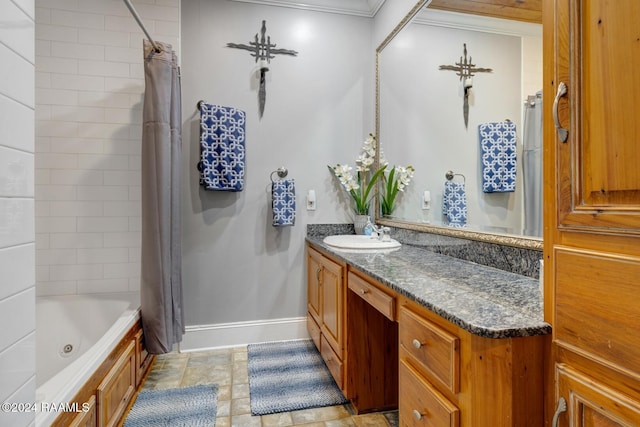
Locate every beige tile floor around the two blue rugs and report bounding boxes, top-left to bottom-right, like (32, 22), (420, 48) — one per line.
(143, 346), (398, 427)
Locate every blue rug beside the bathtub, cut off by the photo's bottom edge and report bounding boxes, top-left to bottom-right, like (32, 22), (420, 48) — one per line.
(124, 384), (218, 427)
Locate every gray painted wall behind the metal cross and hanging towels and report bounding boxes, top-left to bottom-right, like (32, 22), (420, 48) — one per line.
(182, 0), (374, 325)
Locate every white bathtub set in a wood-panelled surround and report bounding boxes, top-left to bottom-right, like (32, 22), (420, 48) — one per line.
(36, 293), (140, 427)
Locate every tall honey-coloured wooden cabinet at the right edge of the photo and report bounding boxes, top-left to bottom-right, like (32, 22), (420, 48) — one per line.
(543, 0), (640, 427)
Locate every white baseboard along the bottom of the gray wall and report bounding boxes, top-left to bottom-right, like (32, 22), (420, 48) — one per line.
(179, 317), (309, 353)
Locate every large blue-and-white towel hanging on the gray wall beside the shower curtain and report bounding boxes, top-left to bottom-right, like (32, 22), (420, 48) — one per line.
(198, 102), (246, 191)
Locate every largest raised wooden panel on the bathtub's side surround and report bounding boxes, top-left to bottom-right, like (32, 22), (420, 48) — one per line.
(97, 340), (136, 427)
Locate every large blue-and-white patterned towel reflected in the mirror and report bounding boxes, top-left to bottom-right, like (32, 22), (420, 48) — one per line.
(478, 121), (516, 193)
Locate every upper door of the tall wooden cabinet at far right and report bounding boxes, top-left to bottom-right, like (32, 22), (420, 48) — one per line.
(545, 0), (640, 235)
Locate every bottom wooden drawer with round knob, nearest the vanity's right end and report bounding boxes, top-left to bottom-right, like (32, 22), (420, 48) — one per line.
(399, 361), (460, 427)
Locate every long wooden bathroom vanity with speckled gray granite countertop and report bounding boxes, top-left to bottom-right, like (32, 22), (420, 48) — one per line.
(307, 235), (551, 427)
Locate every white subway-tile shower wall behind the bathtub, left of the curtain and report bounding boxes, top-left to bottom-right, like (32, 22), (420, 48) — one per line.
(35, 0), (180, 295)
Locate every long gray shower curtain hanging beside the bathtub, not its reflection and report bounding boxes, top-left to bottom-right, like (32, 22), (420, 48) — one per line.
(140, 40), (184, 354)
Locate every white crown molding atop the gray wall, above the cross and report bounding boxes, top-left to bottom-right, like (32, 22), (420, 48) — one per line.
(231, 0), (386, 18)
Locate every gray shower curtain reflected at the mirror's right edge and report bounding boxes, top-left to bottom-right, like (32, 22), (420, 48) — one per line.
(522, 92), (542, 237)
